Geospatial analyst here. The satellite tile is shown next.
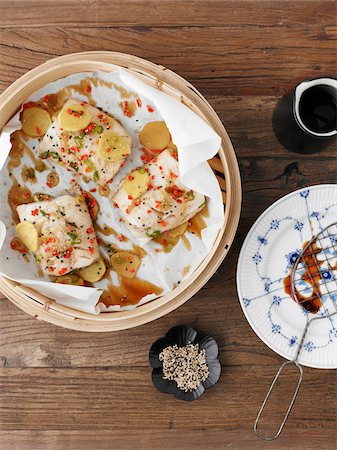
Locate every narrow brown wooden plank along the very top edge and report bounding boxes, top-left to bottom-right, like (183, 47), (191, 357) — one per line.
(0, 0), (335, 28)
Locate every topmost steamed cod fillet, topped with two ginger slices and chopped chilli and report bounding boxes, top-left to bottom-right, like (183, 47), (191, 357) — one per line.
(40, 100), (132, 186)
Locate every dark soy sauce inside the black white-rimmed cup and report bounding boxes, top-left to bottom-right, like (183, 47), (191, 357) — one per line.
(299, 85), (337, 133)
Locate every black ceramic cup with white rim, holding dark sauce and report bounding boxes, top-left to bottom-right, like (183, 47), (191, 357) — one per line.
(273, 78), (337, 153)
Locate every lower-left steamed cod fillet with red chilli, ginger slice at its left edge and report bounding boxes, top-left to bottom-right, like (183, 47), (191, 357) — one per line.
(17, 195), (99, 276)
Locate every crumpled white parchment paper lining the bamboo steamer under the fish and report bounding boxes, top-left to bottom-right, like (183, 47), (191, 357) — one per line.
(0, 70), (224, 314)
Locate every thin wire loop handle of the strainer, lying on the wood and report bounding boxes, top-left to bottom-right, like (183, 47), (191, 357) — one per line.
(254, 360), (303, 441)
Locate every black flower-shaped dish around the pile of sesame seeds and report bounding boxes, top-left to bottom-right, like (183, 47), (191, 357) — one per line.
(149, 325), (221, 401)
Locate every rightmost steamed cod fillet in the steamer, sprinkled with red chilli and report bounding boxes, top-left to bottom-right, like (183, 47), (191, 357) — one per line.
(113, 150), (206, 239)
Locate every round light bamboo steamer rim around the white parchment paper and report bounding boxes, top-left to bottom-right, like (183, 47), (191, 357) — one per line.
(0, 52), (241, 332)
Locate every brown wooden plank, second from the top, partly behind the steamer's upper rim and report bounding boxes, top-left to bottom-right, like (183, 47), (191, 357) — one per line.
(0, 24), (337, 95)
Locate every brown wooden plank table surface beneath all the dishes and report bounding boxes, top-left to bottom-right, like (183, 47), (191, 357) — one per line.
(0, 0), (337, 450)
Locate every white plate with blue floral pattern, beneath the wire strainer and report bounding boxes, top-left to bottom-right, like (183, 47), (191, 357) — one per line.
(237, 184), (337, 369)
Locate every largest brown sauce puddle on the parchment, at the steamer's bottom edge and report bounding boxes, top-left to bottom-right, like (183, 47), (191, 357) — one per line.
(99, 277), (163, 307)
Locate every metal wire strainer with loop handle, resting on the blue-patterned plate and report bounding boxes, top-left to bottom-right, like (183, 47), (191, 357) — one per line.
(254, 222), (337, 441)
